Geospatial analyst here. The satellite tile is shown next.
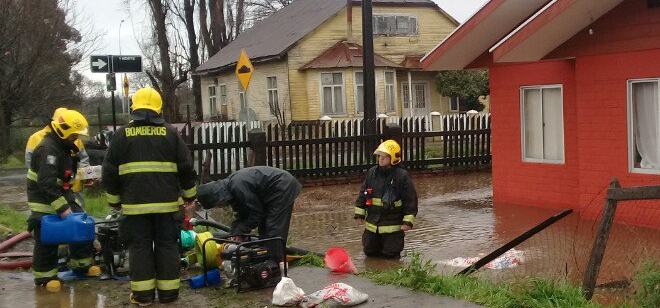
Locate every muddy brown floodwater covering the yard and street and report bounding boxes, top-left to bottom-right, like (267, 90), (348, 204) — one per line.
(0, 172), (660, 307)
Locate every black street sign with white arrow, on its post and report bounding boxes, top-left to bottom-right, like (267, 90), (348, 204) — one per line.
(90, 55), (142, 131)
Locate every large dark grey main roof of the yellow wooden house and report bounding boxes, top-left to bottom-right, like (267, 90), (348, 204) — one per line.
(196, 0), (458, 74)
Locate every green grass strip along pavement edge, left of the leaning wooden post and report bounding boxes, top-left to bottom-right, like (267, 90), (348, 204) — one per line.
(363, 253), (612, 308)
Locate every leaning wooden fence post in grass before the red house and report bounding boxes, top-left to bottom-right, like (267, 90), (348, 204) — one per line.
(582, 178), (621, 300)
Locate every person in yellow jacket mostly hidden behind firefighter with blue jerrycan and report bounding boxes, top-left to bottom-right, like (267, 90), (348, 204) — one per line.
(25, 107), (92, 209)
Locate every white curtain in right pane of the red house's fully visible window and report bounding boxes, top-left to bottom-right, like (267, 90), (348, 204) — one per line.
(542, 88), (564, 160)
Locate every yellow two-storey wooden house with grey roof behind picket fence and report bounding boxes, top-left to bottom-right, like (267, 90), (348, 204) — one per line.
(196, 0), (458, 122)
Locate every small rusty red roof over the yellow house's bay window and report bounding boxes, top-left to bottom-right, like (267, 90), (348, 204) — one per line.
(300, 41), (402, 70)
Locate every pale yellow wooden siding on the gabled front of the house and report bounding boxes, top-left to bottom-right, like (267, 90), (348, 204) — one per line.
(288, 6), (456, 120)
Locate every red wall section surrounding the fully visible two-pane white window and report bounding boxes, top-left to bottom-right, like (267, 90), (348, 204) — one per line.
(490, 61), (578, 208)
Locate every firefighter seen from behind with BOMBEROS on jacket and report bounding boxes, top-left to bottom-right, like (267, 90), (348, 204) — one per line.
(103, 88), (197, 305)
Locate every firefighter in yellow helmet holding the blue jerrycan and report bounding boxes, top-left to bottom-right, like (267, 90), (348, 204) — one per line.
(27, 110), (100, 289)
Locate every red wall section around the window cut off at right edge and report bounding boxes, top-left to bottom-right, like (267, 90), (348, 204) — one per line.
(575, 49), (660, 225)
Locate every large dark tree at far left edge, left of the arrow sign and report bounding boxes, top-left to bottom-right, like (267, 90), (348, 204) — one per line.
(0, 0), (94, 160)
